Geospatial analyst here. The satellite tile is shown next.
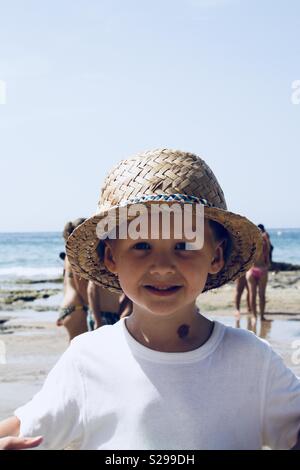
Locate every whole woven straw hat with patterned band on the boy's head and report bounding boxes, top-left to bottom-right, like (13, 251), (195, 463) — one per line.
(66, 149), (262, 292)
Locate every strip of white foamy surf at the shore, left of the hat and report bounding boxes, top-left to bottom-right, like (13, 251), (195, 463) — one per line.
(0, 266), (62, 280)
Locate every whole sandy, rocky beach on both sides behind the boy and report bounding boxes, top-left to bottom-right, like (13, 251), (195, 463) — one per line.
(0, 271), (300, 419)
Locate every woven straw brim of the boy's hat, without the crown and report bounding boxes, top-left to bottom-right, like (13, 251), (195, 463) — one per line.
(66, 202), (262, 293)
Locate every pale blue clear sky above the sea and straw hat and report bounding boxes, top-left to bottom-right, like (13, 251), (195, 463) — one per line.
(0, 0), (300, 232)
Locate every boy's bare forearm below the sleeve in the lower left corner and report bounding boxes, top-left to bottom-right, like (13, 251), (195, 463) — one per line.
(0, 416), (42, 450)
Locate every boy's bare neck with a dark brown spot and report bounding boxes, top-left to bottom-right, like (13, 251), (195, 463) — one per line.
(126, 306), (214, 352)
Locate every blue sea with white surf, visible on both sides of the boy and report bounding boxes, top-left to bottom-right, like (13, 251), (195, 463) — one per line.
(0, 228), (300, 284)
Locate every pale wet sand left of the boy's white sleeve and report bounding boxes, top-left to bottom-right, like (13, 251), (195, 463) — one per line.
(0, 312), (68, 420)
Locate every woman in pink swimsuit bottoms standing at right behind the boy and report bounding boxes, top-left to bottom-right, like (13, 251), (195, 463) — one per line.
(246, 225), (270, 320)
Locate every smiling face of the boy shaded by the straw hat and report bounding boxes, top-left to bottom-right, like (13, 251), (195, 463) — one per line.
(104, 215), (224, 316)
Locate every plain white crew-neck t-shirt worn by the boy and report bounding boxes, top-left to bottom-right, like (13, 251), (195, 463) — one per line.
(15, 319), (300, 450)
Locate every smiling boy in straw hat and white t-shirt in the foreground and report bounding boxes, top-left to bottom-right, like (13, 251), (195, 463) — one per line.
(0, 149), (300, 450)
